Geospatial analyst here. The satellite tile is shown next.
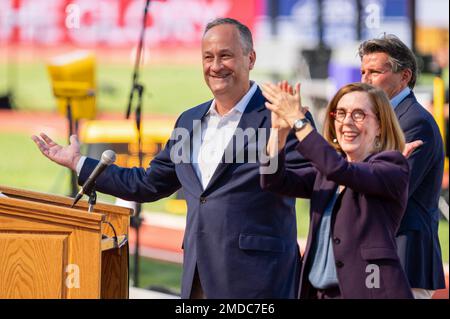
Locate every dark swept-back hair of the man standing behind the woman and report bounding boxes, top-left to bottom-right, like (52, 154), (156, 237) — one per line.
(358, 34), (418, 89)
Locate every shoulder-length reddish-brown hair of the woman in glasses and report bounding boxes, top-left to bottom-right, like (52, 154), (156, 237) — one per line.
(323, 83), (405, 152)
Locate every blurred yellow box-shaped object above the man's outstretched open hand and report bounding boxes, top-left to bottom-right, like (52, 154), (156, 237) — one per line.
(47, 51), (96, 120)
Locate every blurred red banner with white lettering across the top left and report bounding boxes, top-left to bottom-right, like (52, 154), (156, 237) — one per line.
(0, 0), (263, 47)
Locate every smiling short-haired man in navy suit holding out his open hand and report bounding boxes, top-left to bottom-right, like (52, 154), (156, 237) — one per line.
(33, 18), (312, 298)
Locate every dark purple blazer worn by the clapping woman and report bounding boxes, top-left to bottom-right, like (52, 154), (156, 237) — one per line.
(261, 131), (412, 299)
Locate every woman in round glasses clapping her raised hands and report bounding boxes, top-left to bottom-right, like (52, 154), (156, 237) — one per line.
(261, 83), (412, 299)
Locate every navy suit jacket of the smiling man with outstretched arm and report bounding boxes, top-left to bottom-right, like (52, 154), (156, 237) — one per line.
(79, 88), (312, 298)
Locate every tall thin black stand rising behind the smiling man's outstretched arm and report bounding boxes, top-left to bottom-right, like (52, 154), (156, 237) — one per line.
(126, 0), (150, 287)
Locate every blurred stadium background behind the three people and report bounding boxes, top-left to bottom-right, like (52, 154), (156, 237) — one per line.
(0, 0), (449, 296)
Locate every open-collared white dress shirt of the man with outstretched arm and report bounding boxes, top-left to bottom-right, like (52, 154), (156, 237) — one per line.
(76, 82), (258, 189)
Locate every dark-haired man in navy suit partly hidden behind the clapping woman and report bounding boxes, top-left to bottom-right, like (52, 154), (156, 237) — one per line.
(359, 35), (445, 298)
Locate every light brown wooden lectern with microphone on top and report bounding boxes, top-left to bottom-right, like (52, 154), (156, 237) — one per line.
(0, 185), (132, 299)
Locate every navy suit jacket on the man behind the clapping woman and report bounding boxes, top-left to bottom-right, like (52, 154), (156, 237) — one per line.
(395, 92), (445, 290)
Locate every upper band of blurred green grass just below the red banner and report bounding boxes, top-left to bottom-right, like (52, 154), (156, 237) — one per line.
(0, 63), (211, 114)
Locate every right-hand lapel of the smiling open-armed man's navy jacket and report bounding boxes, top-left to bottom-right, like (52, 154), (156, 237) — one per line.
(205, 87), (266, 191)
